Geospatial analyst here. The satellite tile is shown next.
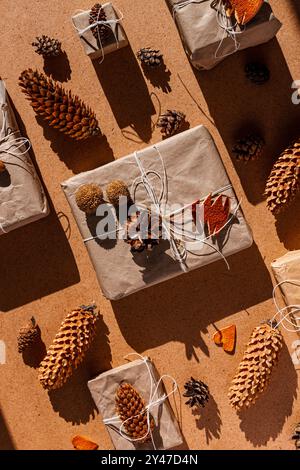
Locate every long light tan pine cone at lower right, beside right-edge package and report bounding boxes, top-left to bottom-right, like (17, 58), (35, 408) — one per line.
(228, 322), (283, 410)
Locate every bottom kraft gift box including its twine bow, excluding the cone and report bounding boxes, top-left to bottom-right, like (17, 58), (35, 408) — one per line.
(88, 354), (183, 450)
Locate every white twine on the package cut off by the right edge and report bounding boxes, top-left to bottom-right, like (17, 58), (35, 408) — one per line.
(271, 279), (300, 332)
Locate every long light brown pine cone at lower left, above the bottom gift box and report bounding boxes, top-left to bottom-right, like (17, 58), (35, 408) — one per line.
(38, 305), (99, 390)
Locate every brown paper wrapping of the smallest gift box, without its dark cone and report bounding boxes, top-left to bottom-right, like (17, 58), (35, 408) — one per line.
(72, 3), (128, 60)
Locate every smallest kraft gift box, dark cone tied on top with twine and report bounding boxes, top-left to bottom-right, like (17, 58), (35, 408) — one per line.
(72, 3), (128, 61)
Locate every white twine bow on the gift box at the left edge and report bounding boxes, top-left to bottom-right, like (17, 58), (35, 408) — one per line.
(0, 103), (31, 233)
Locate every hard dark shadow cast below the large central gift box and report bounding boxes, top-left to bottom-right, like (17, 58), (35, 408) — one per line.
(112, 244), (272, 361)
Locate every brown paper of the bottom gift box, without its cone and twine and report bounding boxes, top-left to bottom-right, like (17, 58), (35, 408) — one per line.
(88, 358), (182, 450)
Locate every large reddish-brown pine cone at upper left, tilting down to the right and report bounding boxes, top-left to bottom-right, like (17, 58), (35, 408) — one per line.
(20, 69), (100, 140)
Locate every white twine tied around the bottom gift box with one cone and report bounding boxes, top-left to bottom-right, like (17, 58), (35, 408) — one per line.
(103, 353), (178, 450)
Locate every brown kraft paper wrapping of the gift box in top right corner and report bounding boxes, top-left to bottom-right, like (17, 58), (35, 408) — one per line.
(167, 0), (282, 70)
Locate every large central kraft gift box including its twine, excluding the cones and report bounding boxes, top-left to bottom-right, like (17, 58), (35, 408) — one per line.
(62, 125), (253, 300)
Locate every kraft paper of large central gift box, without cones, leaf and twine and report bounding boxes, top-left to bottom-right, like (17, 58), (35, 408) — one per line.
(62, 125), (253, 300)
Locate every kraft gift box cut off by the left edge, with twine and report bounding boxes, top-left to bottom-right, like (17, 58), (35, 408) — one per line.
(0, 81), (49, 235)
